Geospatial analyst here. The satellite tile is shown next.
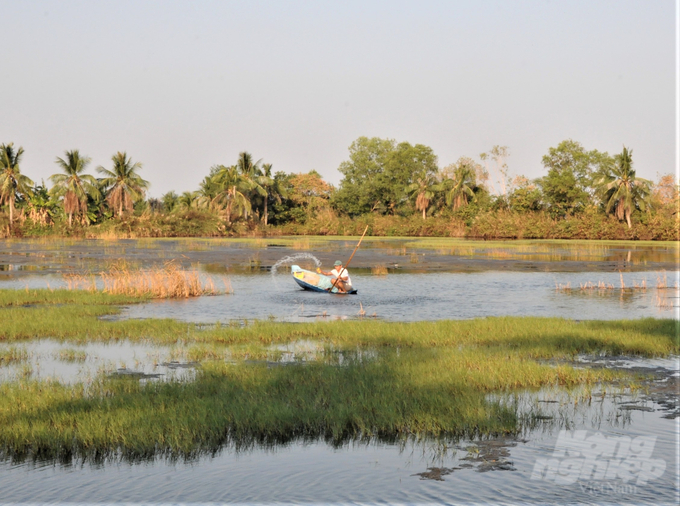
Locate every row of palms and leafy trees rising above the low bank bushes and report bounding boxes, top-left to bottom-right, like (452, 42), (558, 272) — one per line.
(0, 137), (678, 239)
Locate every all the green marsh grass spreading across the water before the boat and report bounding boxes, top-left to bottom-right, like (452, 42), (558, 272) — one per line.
(0, 291), (680, 462)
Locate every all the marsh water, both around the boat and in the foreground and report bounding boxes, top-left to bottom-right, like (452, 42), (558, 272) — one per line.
(0, 238), (680, 504)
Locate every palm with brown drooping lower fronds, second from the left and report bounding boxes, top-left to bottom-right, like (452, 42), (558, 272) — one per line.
(49, 149), (99, 228)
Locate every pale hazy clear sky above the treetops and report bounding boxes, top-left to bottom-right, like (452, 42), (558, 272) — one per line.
(0, 0), (677, 197)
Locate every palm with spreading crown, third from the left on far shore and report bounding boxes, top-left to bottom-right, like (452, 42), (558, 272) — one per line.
(97, 151), (151, 218)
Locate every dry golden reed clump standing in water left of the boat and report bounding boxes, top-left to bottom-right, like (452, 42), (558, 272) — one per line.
(67, 262), (233, 299)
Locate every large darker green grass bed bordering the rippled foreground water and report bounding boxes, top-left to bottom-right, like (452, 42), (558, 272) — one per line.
(0, 349), (628, 461)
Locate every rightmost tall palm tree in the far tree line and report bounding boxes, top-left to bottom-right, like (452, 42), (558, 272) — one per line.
(595, 146), (652, 228)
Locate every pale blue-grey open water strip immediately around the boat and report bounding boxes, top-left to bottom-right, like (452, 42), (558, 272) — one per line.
(115, 269), (678, 322)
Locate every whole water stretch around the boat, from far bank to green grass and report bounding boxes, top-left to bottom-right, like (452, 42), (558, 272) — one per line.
(0, 237), (680, 323)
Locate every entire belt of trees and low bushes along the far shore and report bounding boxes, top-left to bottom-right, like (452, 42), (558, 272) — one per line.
(0, 137), (680, 240)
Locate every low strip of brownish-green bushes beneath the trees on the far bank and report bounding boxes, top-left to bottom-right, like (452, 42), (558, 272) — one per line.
(6, 210), (680, 241)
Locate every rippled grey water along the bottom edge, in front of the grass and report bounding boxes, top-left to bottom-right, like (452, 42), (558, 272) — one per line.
(0, 360), (680, 504)
